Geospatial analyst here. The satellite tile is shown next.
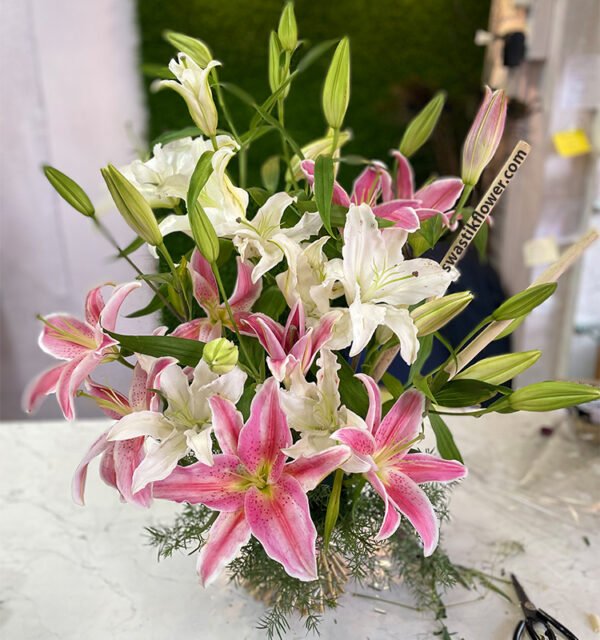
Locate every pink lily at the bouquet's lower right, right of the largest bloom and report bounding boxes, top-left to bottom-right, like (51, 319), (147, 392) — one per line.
(331, 374), (467, 556)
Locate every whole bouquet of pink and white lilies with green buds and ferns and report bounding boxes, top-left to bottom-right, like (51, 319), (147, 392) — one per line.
(25, 3), (600, 636)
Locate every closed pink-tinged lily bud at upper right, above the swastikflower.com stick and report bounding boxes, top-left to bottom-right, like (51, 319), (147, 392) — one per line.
(461, 87), (508, 186)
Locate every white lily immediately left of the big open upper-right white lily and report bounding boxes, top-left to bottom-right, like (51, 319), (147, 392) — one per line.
(233, 192), (322, 282)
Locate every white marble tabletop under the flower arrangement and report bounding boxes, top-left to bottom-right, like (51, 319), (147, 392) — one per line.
(0, 413), (600, 640)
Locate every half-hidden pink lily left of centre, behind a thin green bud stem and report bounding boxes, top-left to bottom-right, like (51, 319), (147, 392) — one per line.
(172, 249), (262, 342)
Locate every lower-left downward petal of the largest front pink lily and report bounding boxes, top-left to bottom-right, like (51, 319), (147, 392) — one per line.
(198, 509), (251, 587)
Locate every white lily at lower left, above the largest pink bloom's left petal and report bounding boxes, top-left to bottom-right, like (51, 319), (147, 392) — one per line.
(107, 360), (246, 493)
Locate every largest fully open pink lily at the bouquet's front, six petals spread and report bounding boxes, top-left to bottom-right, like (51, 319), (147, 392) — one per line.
(153, 378), (350, 586)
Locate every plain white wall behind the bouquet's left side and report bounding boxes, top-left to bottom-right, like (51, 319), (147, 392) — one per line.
(0, 0), (155, 419)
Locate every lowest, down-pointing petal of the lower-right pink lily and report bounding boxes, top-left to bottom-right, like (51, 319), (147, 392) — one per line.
(385, 469), (439, 557)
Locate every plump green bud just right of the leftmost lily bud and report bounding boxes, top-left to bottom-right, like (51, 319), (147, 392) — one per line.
(100, 164), (163, 247)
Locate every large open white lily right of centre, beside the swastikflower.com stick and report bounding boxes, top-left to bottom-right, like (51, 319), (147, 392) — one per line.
(327, 204), (458, 364)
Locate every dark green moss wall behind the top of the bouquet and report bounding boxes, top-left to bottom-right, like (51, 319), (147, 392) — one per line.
(138, 0), (489, 183)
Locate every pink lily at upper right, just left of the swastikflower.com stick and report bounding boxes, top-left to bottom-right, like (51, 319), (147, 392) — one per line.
(301, 158), (463, 232)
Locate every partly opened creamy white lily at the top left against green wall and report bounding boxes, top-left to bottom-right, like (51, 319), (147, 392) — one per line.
(152, 53), (221, 138)
